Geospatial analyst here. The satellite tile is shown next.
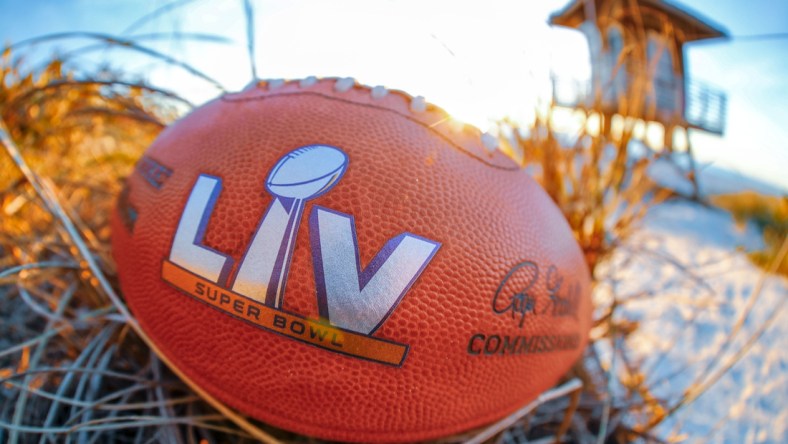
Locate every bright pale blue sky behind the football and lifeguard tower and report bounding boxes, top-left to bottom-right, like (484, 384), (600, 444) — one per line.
(0, 0), (788, 190)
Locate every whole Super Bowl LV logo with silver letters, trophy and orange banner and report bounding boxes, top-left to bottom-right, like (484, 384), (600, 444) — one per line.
(162, 145), (440, 366)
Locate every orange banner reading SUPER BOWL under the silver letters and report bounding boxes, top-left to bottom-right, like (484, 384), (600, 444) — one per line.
(161, 260), (408, 366)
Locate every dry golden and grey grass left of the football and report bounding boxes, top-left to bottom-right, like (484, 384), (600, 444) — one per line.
(0, 50), (264, 443)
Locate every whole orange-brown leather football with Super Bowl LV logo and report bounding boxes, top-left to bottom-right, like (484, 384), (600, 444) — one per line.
(111, 78), (592, 442)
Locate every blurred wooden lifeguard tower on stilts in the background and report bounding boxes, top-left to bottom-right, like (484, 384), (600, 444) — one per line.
(549, 0), (727, 149)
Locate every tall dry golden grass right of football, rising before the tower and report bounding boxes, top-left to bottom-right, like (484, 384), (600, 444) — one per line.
(490, 0), (728, 442)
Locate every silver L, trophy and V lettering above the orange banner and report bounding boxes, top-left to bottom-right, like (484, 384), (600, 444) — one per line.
(170, 145), (440, 334)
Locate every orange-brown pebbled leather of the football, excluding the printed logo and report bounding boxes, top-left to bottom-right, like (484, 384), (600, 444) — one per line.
(112, 79), (592, 442)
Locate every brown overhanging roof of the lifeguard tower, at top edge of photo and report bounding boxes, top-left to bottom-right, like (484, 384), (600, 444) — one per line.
(549, 0), (728, 42)
